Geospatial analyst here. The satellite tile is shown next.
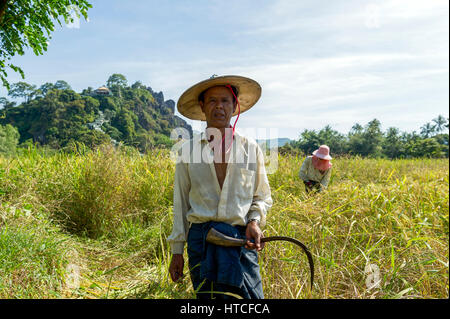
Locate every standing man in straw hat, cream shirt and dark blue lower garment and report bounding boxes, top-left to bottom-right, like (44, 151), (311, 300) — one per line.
(167, 76), (272, 298)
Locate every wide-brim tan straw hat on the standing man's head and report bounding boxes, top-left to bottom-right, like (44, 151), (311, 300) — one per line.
(177, 75), (261, 121)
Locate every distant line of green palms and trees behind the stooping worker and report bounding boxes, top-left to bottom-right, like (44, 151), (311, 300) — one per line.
(280, 115), (449, 159)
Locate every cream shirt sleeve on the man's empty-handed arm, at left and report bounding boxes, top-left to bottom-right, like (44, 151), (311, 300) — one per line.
(167, 160), (191, 254)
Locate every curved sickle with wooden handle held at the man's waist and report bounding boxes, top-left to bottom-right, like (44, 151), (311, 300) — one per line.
(206, 228), (314, 289)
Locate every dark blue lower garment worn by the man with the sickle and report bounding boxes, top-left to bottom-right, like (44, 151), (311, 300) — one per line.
(187, 222), (264, 299)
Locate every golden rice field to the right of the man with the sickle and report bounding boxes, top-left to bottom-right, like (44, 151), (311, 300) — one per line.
(262, 157), (448, 298)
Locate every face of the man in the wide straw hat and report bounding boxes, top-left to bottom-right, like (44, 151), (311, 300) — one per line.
(200, 86), (236, 128)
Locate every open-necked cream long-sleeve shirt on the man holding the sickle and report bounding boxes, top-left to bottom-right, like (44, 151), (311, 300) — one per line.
(167, 132), (272, 254)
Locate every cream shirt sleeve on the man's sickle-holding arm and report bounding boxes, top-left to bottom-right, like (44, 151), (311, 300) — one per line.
(247, 147), (273, 227)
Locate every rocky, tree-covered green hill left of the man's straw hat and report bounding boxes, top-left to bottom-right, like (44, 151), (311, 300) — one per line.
(0, 74), (192, 152)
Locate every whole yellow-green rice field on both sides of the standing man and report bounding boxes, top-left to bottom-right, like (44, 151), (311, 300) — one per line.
(0, 148), (449, 298)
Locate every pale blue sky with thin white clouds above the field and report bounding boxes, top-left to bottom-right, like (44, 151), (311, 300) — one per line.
(0, 0), (449, 139)
